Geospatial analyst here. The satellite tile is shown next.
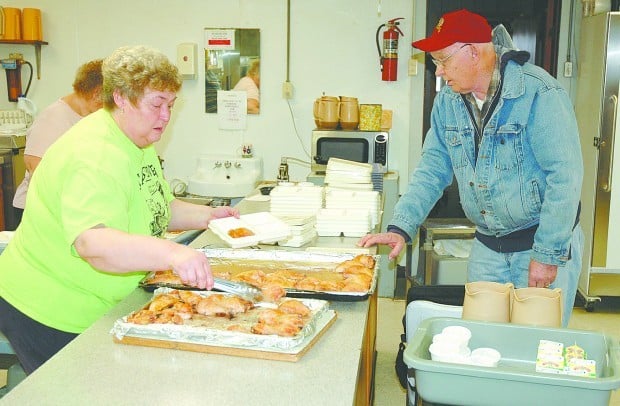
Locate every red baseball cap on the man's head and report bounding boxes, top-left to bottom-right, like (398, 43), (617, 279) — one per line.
(411, 9), (491, 52)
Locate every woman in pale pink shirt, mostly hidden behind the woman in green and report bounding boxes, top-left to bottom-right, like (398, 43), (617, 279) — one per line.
(13, 59), (103, 224)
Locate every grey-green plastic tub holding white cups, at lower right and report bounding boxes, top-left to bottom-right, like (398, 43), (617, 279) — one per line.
(404, 318), (620, 406)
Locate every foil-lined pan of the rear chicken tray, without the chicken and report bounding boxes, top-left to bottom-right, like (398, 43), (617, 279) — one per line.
(139, 248), (379, 302)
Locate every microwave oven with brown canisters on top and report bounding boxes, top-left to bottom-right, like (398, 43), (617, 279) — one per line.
(311, 130), (390, 173)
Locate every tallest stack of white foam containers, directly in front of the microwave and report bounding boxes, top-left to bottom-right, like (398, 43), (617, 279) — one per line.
(325, 158), (373, 190)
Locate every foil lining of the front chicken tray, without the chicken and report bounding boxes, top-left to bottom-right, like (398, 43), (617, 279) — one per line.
(110, 288), (336, 352)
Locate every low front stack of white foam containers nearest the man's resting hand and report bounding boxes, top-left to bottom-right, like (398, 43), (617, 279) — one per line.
(316, 209), (371, 237)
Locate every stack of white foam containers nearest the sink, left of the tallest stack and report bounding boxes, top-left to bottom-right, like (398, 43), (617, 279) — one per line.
(269, 182), (323, 217)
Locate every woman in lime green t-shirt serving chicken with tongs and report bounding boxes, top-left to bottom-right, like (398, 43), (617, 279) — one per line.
(0, 46), (238, 374)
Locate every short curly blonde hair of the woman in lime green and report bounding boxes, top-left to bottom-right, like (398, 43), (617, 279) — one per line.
(102, 45), (183, 111)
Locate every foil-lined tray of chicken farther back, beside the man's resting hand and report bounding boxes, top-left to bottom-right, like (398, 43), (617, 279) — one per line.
(140, 249), (378, 301)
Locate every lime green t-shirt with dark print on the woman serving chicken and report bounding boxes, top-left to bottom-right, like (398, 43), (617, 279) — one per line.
(0, 110), (173, 333)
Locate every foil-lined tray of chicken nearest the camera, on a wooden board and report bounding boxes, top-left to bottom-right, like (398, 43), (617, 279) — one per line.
(110, 288), (336, 351)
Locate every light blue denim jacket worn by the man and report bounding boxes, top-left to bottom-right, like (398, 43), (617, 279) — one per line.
(388, 26), (583, 265)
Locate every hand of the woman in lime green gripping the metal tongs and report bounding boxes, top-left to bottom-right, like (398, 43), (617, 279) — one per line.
(170, 244), (213, 290)
